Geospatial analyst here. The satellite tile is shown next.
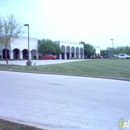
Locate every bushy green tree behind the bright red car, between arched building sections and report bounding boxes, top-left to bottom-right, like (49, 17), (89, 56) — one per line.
(38, 39), (62, 55)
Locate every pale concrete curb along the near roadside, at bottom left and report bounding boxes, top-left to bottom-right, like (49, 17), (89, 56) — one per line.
(0, 117), (54, 130)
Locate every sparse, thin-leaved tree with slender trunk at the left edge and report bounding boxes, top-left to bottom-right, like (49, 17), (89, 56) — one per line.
(0, 15), (22, 64)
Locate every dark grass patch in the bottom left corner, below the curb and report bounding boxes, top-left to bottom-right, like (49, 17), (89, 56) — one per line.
(0, 119), (43, 130)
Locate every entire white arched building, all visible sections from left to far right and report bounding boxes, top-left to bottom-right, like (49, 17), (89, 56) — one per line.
(0, 37), (100, 59)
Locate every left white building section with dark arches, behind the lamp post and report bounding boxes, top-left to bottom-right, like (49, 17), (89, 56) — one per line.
(0, 37), (38, 59)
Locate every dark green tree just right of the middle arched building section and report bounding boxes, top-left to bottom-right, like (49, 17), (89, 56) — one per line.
(80, 42), (96, 58)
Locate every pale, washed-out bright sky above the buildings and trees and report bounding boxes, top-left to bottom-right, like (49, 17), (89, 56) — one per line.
(0, 0), (130, 49)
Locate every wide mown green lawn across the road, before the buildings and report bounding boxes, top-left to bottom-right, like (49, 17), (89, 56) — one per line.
(0, 59), (130, 79)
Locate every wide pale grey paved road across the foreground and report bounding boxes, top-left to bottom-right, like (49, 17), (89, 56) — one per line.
(0, 71), (130, 130)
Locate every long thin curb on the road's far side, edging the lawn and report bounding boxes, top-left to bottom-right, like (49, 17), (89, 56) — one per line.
(0, 69), (130, 81)
